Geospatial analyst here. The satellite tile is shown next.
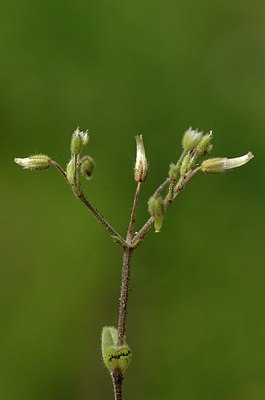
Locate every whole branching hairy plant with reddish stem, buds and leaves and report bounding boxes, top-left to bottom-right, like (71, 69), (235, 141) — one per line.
(15, 128), (253, 400)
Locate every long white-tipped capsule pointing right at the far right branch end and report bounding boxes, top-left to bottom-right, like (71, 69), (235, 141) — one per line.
(201, 152), (254, 174)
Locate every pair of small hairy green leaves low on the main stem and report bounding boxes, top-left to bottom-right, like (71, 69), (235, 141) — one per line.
(101, 326), (132, 373)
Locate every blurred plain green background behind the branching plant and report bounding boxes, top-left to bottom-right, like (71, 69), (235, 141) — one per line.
(0, 0), (265, 400)
